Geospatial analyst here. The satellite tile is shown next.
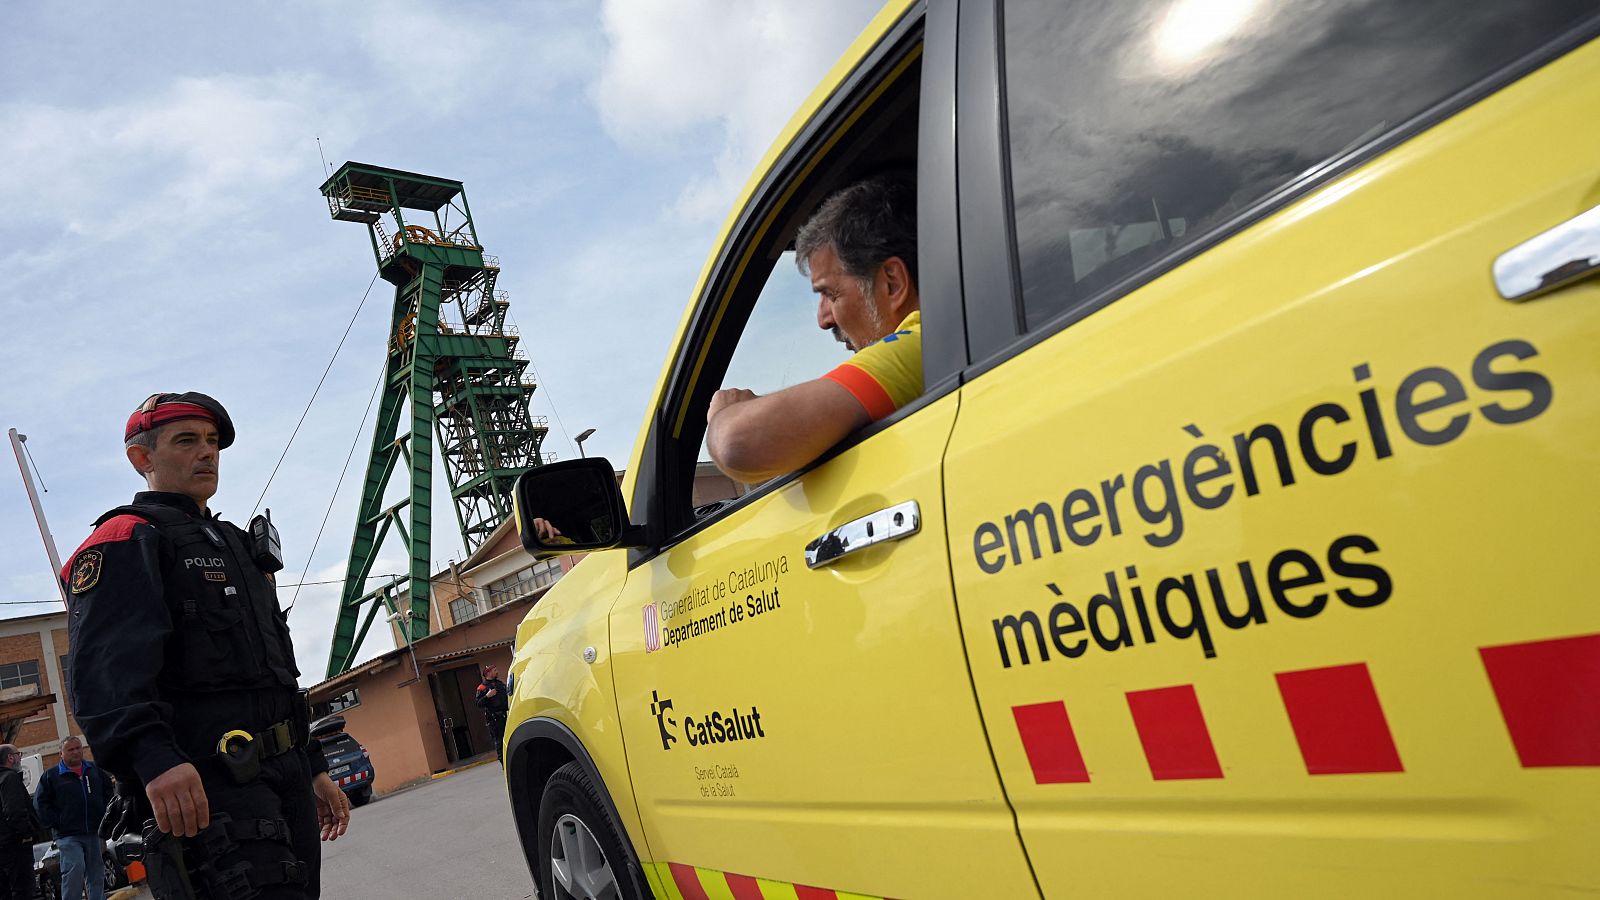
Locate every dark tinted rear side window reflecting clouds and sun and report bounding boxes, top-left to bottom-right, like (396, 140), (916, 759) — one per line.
(1003, 0), (1595, 330)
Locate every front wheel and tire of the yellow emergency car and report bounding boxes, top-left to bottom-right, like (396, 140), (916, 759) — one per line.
(538, 762), (651, 900)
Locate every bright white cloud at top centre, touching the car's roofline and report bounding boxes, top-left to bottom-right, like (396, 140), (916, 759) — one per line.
(595, 0), (878, 221)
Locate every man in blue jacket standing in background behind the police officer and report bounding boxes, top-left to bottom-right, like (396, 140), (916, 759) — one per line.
(34, 737), (112, 900)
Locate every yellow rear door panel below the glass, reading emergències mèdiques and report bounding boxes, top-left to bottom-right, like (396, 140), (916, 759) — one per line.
(946, 3), (1600, 897)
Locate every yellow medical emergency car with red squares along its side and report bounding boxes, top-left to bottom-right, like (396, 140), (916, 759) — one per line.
(506, 0), (1600, 900)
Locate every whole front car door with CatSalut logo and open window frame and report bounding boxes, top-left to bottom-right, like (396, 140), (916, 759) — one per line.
(611, 13), (1035, 898)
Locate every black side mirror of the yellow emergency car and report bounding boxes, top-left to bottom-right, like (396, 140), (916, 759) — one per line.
(512, 456), (638, 559)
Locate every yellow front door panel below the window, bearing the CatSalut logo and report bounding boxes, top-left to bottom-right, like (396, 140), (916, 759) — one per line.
(611, 394), (1034, 897)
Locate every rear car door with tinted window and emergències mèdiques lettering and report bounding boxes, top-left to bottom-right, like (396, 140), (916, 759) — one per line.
(946, 0), (1600, 897)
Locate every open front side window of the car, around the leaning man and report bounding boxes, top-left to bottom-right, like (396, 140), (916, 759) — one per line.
(640, 40), (922, 543)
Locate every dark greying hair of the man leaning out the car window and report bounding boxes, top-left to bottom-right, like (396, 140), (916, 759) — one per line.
(795, 175), (917, 296)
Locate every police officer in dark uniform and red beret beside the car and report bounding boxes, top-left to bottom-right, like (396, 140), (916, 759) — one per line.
(62, 392), (349, 900)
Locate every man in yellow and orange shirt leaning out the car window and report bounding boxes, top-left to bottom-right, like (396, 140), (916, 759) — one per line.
(706, 175), (922, 484)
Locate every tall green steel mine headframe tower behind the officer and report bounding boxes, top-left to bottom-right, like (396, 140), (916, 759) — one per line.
(322, 162), (546, 677)
